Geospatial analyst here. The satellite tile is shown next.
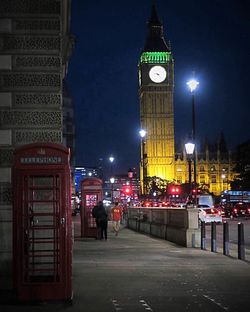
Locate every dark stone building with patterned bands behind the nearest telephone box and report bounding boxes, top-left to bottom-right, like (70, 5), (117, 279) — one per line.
(0, 0), (72, 286)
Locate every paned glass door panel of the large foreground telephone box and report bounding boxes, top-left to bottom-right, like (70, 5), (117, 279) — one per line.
(23, 175), (62, 282)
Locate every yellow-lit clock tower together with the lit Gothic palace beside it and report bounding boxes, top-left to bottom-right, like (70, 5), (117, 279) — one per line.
(138, 4), (236, 195)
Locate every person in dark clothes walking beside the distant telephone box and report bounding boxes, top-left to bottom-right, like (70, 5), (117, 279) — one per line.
(93, 201), (108, 240)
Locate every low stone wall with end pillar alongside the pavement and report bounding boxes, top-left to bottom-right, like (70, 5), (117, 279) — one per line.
(127, 207), (201, 247)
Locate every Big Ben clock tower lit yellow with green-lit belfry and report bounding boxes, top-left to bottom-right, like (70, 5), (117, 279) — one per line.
(138, 4), (175, 190)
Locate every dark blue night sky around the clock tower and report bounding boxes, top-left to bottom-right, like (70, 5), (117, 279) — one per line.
(66, 0), (250, 174)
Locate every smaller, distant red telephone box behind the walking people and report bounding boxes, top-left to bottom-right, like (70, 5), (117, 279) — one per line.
(81, 177), (103, 237)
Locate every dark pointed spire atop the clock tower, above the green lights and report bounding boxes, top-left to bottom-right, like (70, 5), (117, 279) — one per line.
(144, 0), (171, 52)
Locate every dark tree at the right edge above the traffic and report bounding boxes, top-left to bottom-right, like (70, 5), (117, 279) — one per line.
(231, 140), (250, 190)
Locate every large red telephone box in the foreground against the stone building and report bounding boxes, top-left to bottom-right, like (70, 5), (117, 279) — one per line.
(13, 143), (72, 300)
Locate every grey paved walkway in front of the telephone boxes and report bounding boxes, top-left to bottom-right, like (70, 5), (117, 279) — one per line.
(0, 216), (250, 312)
